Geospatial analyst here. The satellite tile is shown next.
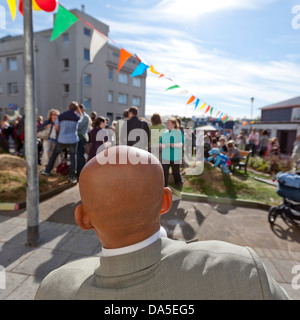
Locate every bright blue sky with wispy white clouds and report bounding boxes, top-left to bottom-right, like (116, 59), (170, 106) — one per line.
(0, 0), (300, 118)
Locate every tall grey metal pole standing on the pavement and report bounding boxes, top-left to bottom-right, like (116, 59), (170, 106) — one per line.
(23, 0), (39, 247)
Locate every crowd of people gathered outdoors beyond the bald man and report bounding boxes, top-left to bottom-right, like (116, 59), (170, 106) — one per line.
(0, 105), (300, 180)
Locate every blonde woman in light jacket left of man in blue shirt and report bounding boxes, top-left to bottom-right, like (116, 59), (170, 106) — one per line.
(38, 109), (61, 168)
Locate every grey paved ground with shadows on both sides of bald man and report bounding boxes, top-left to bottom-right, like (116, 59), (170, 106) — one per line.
(0, 186), (300, 300)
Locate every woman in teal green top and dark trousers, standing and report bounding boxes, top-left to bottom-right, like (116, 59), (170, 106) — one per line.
(159, 118), (184, 189)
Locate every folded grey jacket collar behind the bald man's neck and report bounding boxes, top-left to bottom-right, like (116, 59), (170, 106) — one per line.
(95, 239), (162, 277)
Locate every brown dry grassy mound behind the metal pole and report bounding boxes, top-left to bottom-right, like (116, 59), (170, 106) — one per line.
(0, 154), (68, 203)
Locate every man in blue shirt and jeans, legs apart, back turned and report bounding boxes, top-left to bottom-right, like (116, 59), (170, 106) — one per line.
(41, 101), (82, 183)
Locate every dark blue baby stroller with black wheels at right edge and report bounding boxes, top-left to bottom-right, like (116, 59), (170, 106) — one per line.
(268, 171), (300, 227)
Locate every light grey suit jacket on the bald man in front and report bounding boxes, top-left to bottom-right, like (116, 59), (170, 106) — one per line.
(35, 238), (289, 300)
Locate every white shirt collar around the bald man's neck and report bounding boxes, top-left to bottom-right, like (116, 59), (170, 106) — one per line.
(100, 227), (167, 257)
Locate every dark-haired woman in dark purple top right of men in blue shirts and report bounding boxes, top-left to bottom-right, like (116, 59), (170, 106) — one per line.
(88, 117), (110, 161)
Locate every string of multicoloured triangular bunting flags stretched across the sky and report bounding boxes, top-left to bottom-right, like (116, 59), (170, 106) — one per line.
(7, 0), (234, 125)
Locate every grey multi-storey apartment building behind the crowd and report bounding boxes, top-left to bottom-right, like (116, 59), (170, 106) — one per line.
(0, 9), (146, 121)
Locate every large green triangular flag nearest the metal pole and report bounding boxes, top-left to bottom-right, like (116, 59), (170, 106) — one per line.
(50, 5), (79, 41)
